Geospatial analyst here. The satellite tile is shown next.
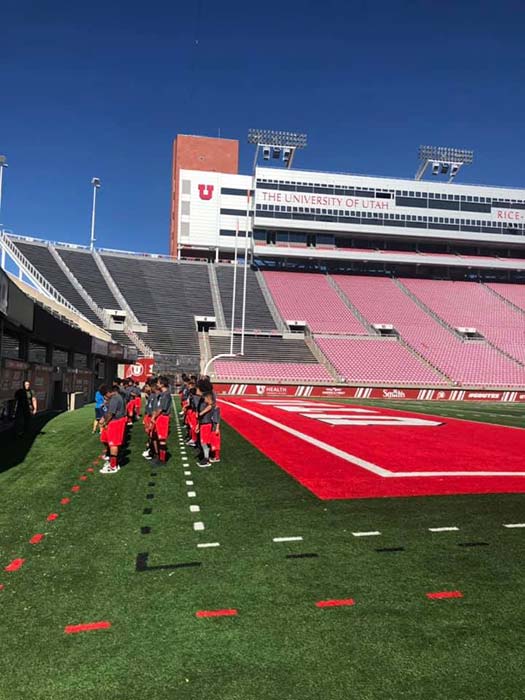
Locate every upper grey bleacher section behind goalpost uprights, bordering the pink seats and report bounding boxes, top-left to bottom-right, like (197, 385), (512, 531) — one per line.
(216, 265), (275, 331)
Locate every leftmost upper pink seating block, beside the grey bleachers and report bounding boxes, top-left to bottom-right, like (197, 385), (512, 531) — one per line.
(263, 272), (367, 335)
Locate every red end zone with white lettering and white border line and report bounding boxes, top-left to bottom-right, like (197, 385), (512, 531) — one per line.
(220, 397), (525, 499)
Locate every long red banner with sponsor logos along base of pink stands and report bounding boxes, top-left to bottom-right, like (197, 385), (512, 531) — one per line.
(215, 383), (525, 403)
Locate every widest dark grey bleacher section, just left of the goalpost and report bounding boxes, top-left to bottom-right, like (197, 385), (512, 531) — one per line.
(102, 253), (214, 366)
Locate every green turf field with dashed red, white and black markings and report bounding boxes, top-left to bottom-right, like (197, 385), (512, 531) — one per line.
(0, 401), (525, 700)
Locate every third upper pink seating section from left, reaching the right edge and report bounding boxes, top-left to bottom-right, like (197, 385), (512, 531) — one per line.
(401, 279), (525, 362)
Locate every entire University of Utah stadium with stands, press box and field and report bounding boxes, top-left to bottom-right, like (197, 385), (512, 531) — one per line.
(0, 129), (525, 700)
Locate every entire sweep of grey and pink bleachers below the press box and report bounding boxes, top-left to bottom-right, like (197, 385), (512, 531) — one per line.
(7, 238), (525, 388)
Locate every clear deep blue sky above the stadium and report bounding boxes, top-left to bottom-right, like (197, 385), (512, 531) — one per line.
(0, 0), (525, 252)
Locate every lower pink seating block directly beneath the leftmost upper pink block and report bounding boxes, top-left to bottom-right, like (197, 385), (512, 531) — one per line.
(317, 337), (447, 385)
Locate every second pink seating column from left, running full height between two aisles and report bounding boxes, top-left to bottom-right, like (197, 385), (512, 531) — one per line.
(335, 275), (525, 386)
